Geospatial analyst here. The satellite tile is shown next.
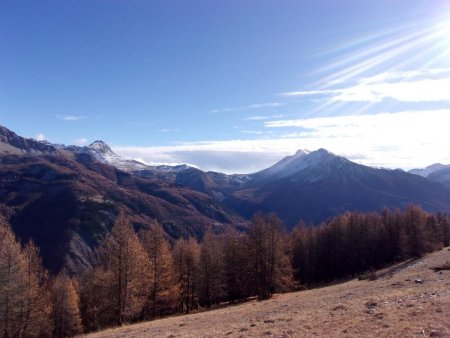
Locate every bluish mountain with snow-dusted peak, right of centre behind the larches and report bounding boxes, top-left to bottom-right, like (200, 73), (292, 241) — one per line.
(225, 149), (450, 227)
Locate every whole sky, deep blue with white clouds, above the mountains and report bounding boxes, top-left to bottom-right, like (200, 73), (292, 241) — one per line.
(0, 0), (450, 173)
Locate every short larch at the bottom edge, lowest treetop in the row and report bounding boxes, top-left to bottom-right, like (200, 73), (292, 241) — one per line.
(53, 273), (83, 337)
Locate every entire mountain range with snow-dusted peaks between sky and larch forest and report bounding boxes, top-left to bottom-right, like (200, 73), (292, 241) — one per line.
(0, 127), (450, 273)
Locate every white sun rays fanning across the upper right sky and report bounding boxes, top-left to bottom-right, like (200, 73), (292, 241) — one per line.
(310, 19), (450, 90)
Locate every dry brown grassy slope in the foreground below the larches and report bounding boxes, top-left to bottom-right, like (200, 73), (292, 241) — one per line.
(83, 249), (450, 338)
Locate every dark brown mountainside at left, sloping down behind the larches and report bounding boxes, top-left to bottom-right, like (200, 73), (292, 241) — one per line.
(0, 125), (245, 272)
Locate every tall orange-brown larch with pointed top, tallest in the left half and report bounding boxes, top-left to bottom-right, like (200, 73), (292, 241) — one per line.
(101, 212), (149, 325)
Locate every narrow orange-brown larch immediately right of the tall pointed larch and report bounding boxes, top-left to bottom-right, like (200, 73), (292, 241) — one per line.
(139, 222), (179, 318)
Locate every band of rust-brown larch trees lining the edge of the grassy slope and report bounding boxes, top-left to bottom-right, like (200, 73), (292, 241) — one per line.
(0, 206), (450, 337)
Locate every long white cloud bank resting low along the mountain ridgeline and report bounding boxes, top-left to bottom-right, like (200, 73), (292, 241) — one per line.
(114, 109), (450, 173)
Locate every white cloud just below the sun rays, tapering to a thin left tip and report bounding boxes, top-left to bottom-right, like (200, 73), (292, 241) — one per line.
(281, 69), (450, 103)
